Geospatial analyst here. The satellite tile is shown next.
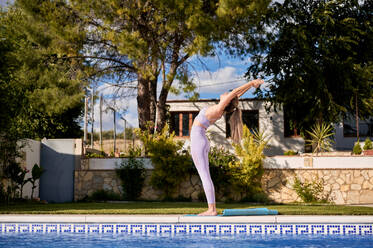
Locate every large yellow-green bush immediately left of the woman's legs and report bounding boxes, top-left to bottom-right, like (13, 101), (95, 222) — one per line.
(135, 125), (192, 199)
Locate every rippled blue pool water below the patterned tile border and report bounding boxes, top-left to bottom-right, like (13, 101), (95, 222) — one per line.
(0, 233), (373, 248)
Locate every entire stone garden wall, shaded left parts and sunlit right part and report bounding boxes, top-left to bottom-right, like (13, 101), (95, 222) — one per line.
(74, 159), (373, 204)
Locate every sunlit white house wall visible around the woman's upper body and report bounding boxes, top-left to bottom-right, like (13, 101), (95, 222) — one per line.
(168, 100), (304, 156)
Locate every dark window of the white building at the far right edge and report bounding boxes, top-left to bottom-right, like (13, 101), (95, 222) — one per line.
(343, 116), (373, 137)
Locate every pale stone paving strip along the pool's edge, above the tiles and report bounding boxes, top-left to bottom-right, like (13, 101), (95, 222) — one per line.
(0, 214), (373, 224)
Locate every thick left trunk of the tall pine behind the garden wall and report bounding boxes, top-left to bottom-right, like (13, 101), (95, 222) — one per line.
(137, 75), (151, 130)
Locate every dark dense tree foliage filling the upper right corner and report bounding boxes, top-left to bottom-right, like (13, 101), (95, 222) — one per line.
(247, 0), (373, 132)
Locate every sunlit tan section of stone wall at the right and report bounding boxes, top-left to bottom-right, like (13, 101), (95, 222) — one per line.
(262, 168), (373, 204)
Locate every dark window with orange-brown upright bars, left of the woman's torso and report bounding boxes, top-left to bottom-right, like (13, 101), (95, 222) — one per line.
(170, 112), (198, 137)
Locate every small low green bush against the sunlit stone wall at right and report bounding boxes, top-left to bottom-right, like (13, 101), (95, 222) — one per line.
(293, 177), (328, 203)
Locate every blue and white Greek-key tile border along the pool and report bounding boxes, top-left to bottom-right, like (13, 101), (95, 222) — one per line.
(0, 223), (373, 235)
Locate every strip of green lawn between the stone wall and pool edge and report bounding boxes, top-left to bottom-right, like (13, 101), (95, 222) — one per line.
(0, 202), (373, 215)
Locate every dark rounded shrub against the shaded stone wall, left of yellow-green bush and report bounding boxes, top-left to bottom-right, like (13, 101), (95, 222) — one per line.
(115, 157), (145, 200)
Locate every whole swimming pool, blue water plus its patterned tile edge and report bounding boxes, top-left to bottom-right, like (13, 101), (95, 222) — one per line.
(0, 223), (373, 248)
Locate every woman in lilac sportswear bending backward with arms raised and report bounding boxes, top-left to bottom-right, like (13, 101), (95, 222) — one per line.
(190, 79), (263, 215)
